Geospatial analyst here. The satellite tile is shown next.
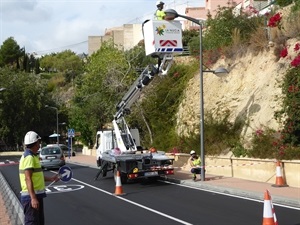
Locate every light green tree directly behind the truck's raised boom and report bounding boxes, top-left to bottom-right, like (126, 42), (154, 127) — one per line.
(70, 42), (136, 144)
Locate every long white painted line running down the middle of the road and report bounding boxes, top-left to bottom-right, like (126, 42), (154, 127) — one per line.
(72, 178), (192, 225)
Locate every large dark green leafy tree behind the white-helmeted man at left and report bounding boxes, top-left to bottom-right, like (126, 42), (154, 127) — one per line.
(0, 68), (51, 145)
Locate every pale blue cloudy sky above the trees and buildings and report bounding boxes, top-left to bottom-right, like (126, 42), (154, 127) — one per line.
(0, 0), (204, 55)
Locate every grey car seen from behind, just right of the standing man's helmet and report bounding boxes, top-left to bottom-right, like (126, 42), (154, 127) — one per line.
(40, 145), (66, 169)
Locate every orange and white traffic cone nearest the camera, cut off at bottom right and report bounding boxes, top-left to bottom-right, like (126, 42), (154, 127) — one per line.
(262, 190), (278, 225)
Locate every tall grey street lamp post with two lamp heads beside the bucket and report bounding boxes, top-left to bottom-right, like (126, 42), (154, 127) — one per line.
(164, 9), (228, 181)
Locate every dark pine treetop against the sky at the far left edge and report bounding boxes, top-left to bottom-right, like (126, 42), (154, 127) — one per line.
(0, 37), (25, 69)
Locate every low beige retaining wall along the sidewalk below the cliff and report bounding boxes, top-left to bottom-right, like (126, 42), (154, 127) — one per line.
(82, 148), (300, 188)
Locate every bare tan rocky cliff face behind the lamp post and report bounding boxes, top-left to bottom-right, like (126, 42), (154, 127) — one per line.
(177, 39), (299, 144)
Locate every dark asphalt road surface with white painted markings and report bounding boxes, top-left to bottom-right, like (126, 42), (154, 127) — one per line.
(0, 157), (300, 225)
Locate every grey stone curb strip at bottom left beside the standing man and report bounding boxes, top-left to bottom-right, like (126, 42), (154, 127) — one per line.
(0, 172), (24, 225)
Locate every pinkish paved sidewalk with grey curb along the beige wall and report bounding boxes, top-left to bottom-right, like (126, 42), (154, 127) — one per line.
(66, 153), (300, 208)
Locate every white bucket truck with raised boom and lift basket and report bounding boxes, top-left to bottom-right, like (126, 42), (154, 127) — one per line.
(95, 20), (183, 183)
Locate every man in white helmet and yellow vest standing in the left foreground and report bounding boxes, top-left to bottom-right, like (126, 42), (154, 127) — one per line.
(19, 131), (59, 225)
